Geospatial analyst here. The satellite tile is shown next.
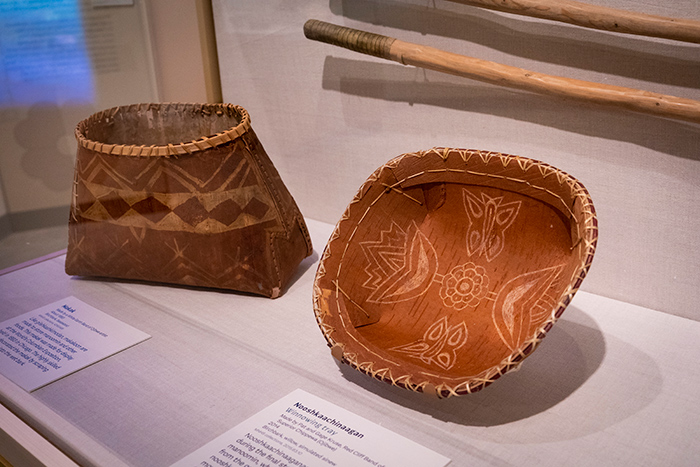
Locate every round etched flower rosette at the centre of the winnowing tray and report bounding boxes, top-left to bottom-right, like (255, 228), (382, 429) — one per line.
(440, 263), (489, 310)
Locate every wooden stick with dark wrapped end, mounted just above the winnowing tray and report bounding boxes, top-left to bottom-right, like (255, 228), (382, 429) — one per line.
(304, 20), (700, 123)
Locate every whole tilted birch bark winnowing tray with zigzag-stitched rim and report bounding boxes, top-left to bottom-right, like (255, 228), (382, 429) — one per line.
(314, 148), (598, 397)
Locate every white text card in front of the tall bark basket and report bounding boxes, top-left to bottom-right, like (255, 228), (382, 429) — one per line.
(0, 296), (151, 391)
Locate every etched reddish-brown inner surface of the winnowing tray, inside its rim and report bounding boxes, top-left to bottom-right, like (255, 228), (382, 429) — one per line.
(331, 179), (582, 378)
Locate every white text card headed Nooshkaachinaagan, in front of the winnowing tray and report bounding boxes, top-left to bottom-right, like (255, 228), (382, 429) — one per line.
(172, 389), (450, 467)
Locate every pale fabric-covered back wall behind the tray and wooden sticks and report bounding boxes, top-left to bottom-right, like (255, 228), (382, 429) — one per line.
(214, 0), (700, 320)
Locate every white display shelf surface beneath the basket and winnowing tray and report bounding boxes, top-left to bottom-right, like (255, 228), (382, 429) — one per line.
(0, 220), (700, 467)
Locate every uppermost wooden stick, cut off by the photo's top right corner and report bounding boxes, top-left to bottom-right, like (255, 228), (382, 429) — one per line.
(451, 0), (700, 44)
